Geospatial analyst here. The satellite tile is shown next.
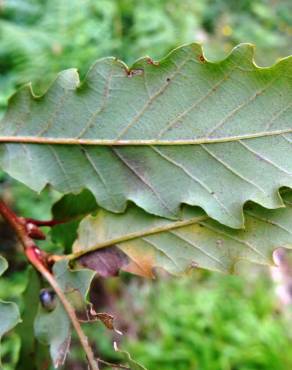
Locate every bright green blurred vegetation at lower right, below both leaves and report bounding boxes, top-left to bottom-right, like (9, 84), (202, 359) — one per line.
(124, 272), (292, 370)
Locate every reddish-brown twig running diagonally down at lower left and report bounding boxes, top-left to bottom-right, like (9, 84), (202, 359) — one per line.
(0, 200), (99, 370)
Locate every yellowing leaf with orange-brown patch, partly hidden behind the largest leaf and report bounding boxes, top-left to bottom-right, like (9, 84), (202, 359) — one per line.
(71, 191), (292, 276)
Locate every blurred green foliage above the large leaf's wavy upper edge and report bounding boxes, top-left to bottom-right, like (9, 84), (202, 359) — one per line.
(0, 0), (292, 108)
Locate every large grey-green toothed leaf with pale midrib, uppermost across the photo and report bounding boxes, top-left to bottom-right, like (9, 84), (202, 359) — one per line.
(0, 44), (292, 227)
